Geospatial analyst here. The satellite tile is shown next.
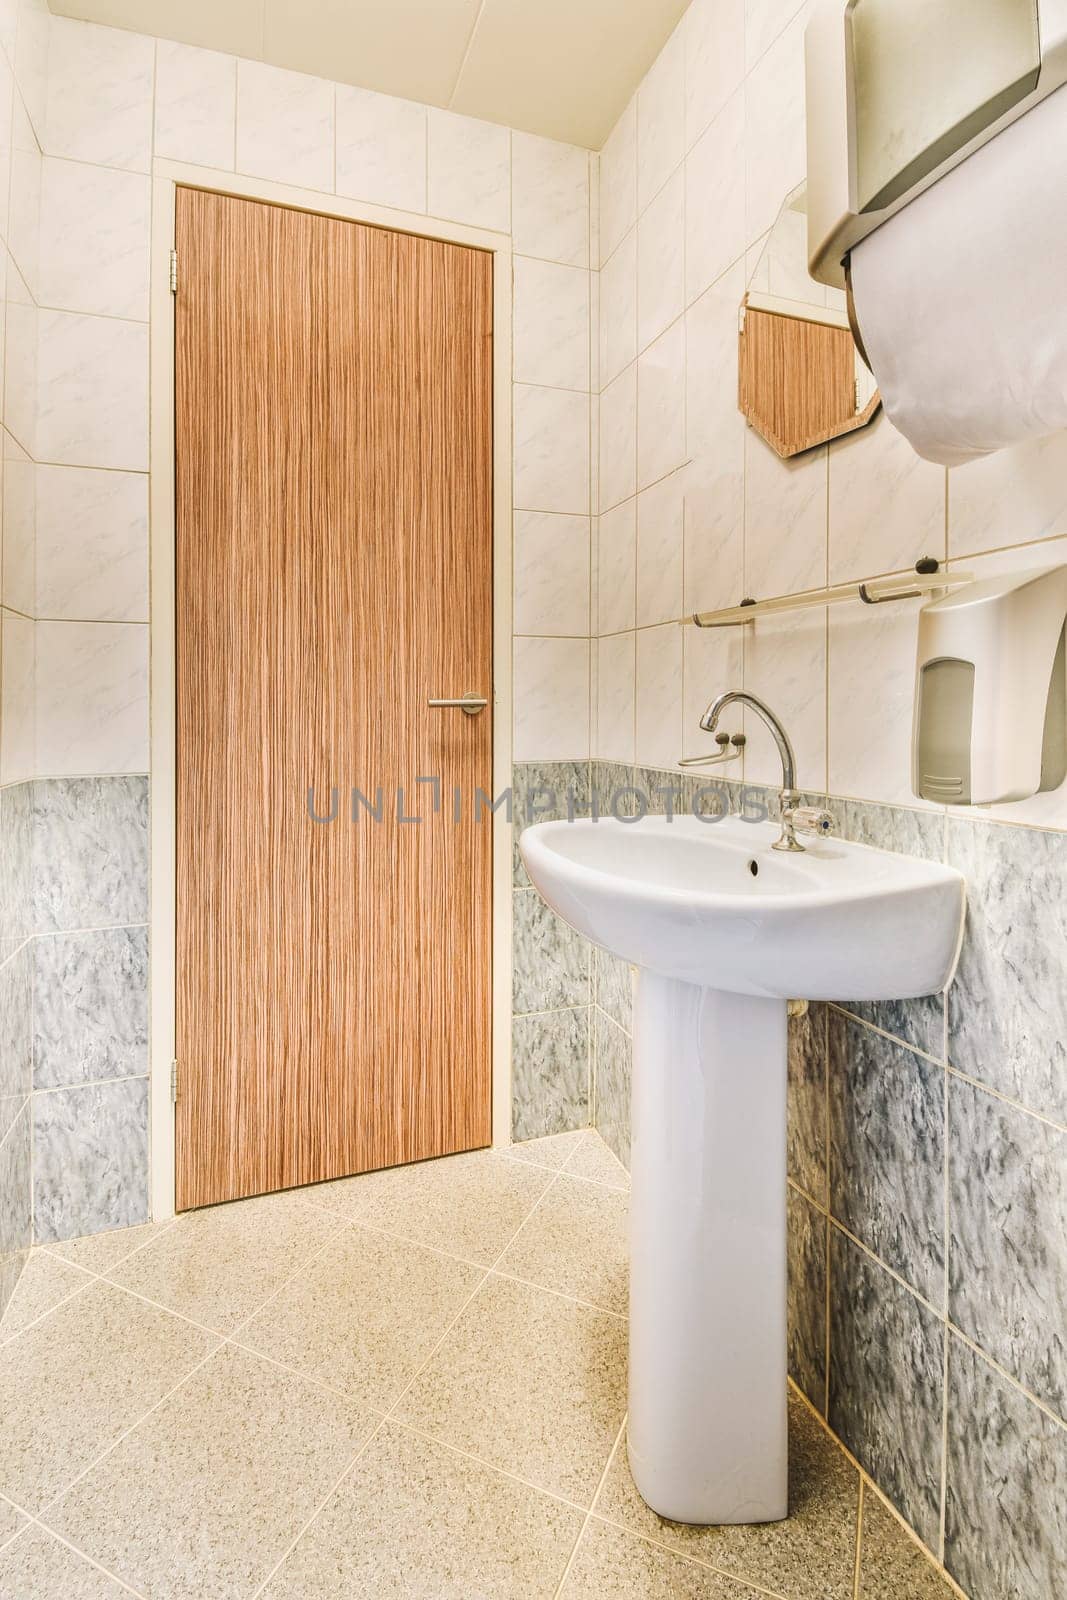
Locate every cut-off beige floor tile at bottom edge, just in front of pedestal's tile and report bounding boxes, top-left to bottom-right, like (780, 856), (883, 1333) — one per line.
(560, 1520), (758, 1600)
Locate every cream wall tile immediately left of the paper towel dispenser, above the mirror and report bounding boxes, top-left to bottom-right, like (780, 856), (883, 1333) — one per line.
(745, 16), (806, 240)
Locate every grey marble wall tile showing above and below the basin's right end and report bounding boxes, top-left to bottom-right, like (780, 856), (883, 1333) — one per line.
(830, 800), (945, 1061)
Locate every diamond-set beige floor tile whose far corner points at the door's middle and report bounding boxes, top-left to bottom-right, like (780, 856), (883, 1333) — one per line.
(240, 1224), (482, 1411)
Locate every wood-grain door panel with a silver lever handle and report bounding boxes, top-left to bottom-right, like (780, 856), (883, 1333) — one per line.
(176, 189), (493, 1210)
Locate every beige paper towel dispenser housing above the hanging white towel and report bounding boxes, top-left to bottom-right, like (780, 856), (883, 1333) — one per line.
(805, 0), (1067, 288)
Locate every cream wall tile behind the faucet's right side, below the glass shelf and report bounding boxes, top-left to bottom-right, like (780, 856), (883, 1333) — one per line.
(744, 610), (827, 792)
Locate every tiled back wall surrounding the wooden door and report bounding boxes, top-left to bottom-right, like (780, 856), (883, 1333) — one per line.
(14, 18), (598, 1238)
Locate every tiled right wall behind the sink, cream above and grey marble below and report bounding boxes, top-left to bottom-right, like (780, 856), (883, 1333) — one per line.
(547, 0), (1067, 1600)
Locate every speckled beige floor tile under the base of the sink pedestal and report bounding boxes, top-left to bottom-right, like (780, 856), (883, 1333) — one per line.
(595, 1398), (859, 1600)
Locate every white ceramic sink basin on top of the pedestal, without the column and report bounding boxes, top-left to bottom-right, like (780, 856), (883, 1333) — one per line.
(520, 816), (963, 1000)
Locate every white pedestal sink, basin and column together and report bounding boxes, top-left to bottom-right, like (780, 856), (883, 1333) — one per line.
(520, 818), (965, 1523)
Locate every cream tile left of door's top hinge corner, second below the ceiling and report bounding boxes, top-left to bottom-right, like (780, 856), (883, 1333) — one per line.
(37, 157), (152, 322)
